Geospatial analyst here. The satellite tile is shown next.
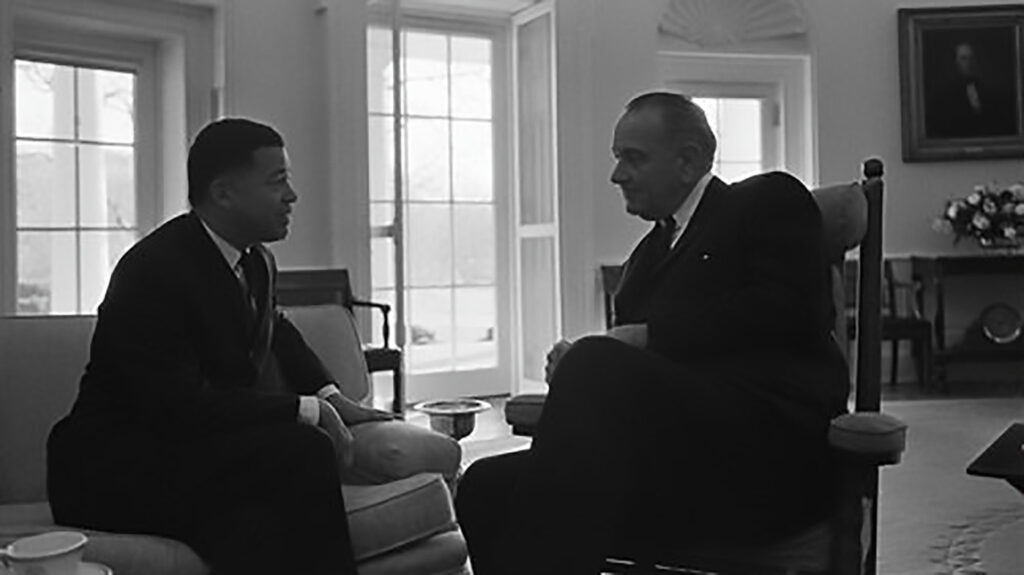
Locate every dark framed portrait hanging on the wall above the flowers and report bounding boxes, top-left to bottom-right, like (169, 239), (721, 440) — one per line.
(898, 4), (1024, 162)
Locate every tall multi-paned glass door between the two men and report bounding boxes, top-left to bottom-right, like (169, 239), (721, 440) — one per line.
(367, 20), (511, 402)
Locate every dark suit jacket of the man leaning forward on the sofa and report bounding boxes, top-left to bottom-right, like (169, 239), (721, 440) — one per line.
(59, 213), (330, 437)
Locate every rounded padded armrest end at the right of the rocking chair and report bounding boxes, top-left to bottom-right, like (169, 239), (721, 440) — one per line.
(828, 412), (906, 466)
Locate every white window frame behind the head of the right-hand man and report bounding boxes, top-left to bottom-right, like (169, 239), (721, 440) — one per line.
(657, 51), (817, 185)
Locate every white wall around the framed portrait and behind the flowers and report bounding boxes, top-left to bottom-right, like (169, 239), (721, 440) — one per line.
(804, 0), (1024, 255)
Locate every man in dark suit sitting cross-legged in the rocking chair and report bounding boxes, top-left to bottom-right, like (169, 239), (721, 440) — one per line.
(456, 92), (849, 575)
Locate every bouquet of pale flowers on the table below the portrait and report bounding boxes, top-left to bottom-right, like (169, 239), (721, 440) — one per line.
(935, 183), (1024, 249)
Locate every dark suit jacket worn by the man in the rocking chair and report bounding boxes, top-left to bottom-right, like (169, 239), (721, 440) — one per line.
(613, 172), (849, 430)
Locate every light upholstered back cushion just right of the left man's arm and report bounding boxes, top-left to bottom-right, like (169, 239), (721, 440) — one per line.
(284, 304), (371, 401)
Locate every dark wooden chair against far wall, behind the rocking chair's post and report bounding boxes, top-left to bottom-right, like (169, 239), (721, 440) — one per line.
(844, 259), (933, 388)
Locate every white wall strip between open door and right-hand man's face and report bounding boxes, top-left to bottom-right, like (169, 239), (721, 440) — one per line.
(555, 0), (662, 337)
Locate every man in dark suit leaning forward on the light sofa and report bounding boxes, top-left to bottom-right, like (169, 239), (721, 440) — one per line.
(48, 119), (390, 575)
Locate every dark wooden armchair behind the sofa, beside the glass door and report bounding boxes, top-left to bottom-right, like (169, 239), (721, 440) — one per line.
(276, 269), (406, 415)
